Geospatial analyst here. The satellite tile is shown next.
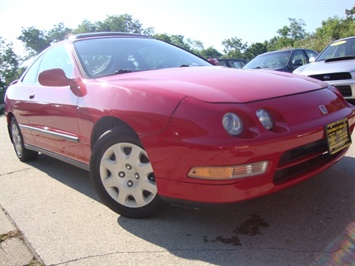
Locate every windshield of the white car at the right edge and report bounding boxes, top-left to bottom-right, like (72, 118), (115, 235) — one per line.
(316, 38), (355, 61)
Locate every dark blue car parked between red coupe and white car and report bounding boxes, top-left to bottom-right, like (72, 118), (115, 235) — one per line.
(243, 48), (318, 72)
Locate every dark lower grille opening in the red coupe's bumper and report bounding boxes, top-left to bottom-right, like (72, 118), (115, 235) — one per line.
(273, 139), (337, 184)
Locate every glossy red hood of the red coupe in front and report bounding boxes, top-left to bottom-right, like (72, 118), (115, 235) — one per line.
(100, 66), (327, 103)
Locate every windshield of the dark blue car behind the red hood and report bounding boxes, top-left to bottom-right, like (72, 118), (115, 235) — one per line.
(243, 51), (291, 69)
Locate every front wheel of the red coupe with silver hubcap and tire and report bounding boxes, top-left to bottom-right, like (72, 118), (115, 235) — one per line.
(90, 128), (165, 218)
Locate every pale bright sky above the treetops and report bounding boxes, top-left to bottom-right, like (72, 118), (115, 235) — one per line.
(0, 0), (355, 52)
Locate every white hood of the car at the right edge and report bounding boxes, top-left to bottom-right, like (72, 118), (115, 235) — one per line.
(293, 59), (355, 76)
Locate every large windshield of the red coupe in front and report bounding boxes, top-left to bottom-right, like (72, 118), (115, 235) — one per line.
(74, 37), (210, 78)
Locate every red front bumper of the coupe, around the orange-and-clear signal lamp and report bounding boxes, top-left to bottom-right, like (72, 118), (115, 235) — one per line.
(142, 91), (355, 204)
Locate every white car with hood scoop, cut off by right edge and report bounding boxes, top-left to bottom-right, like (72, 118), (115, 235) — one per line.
(293, 36), (355, 103)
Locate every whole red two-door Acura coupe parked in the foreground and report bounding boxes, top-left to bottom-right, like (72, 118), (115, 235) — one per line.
(5, 33), (355, 217)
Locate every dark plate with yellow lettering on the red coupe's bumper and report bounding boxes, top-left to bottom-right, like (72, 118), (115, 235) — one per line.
(325, 119), (351, 155)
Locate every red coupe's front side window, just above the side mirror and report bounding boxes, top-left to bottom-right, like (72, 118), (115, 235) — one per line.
(38, 46), (74, 78)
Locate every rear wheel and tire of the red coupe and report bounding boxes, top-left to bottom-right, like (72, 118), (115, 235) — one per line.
(10, 117), (38, 162)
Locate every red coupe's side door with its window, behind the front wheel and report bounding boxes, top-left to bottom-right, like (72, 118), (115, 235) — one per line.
(27, 45), (84, 162)
